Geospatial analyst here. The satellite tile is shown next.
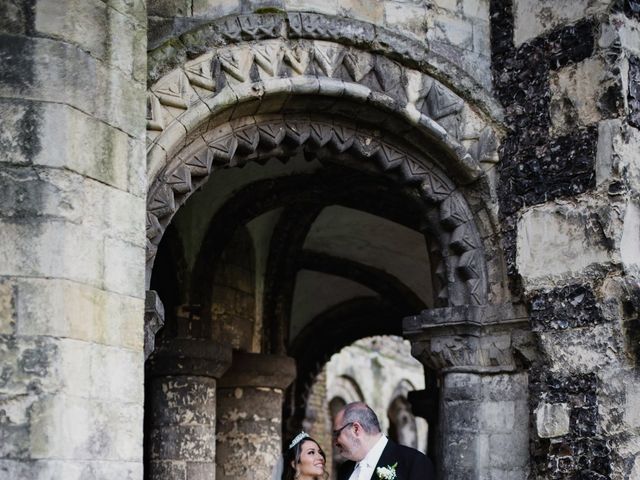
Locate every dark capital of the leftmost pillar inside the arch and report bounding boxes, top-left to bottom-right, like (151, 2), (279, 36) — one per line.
(147, 338), (231, 379)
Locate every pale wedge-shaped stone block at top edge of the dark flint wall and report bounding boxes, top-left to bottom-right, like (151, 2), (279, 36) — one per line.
(513, 0), (610, 46)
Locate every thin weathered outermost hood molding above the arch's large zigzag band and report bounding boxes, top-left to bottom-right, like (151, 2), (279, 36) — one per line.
(149, 12), (501, 118)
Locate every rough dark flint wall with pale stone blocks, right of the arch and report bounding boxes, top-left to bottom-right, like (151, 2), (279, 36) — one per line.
(491, 0), (640, 479)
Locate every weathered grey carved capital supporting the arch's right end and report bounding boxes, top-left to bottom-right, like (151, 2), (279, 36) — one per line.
(403, 304), (534, 373)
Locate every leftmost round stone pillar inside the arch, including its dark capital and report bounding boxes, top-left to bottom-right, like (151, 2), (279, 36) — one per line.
(147, 339), (231, 480)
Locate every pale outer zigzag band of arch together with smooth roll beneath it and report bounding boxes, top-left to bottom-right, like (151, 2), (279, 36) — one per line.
(147, 35), (497, 181)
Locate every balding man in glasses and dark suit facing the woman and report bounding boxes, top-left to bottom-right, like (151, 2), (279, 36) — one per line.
(333, 402), (436, 480)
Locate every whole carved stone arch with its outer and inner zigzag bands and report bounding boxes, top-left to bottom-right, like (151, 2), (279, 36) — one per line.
(147, 32), (504, 305)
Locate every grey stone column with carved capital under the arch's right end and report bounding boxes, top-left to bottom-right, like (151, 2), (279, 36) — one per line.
(404, 306), (529, 480)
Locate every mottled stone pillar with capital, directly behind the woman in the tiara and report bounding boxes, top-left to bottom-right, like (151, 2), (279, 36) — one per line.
(216, 352), (296, 480)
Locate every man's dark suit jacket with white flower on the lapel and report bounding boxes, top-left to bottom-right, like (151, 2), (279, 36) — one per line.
(338, 440), (436, 480)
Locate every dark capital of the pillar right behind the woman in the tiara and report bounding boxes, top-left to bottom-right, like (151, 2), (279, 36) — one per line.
(218, 351), (296, 390)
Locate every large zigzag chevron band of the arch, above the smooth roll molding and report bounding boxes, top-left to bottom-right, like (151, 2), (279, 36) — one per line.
(147, 38), (496, 165)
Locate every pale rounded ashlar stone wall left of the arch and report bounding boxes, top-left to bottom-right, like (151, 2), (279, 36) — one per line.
(0, 0), (146, 480)
